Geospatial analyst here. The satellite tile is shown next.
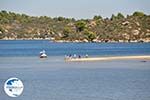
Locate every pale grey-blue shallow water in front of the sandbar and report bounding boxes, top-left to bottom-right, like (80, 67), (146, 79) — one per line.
(0, 56), (150, 100)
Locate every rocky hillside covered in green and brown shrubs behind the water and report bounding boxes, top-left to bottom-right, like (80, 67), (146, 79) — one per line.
(0, 11), (150, 42)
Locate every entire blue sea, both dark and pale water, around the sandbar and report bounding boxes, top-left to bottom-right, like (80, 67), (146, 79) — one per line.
(0, 40), (150, 100)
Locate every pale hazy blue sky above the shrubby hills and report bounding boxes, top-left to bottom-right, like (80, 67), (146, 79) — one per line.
(0, 0), (150, 18)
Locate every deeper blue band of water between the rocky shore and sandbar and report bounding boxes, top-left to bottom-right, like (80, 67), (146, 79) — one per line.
(0, 40), (150, 57)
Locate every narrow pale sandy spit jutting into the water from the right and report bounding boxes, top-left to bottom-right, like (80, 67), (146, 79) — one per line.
(65, 55), (150, 61)
